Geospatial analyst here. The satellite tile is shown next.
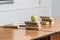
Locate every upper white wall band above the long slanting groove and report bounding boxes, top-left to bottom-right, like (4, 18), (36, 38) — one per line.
(0, 0), (51, 11)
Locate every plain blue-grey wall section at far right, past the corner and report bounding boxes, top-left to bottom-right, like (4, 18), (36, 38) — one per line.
(52, 0), (60, 17)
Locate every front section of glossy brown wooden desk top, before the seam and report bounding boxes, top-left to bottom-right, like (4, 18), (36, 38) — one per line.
(0, 28), (53, 40)
